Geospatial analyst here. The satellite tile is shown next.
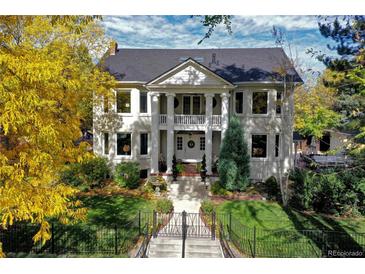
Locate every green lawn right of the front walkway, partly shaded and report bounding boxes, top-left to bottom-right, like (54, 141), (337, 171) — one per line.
(217, 201), (365, 257)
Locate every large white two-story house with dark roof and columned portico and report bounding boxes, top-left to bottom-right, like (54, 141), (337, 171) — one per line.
(93, 46), (302, 180)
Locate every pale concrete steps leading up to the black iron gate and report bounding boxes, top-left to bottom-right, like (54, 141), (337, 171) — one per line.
(147, 237), (223, 258)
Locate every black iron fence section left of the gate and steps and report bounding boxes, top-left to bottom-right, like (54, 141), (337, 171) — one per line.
(0, 218), (143, 257)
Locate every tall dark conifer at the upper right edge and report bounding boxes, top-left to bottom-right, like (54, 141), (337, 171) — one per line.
(309, 16), (365, 154)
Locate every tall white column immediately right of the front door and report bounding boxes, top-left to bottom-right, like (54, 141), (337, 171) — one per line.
(205, 93), (214, 175)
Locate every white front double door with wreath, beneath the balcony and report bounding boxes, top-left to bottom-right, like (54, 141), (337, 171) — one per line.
(175, 134), (205, 163)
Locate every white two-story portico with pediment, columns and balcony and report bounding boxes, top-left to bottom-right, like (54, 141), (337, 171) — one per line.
(146, 59), (234, 175)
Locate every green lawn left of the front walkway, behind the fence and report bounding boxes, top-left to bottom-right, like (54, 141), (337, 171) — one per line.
(4, 195), (154, 257)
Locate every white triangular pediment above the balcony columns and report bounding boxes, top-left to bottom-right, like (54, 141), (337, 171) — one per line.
(147, 58), (233, 87)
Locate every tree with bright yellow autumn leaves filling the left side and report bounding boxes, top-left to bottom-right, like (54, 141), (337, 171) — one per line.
(0, 16), (115, 253)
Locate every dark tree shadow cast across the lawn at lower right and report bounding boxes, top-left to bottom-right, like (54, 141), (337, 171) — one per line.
(283, 207), (365, 257)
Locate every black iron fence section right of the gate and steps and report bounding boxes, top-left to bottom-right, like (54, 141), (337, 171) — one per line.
(217, 214), (365, 258)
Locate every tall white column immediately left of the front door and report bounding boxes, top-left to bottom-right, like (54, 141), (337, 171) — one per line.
(166, 93), (175, 173)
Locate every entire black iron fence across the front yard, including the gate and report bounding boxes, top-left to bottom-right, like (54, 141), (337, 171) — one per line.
(0, 212), (365, 258)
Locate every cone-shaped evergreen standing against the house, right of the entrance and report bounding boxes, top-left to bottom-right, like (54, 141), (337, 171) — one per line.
(218, 116), (250, 191)
